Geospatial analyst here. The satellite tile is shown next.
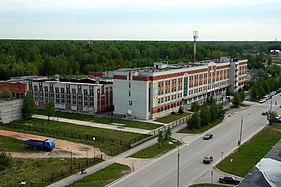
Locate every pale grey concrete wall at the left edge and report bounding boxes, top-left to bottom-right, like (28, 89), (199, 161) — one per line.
(0, 99), (23, 124)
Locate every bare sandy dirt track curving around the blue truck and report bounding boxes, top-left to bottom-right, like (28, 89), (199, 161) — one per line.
(0, 130), (110, 160)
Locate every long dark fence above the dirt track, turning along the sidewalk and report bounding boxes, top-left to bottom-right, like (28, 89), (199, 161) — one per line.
(3, 121), (150, 155)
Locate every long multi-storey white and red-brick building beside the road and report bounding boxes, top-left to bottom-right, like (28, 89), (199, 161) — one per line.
(113, 57), (248, 120)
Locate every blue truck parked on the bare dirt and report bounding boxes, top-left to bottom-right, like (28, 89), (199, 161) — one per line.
(23, 139), (56, 151)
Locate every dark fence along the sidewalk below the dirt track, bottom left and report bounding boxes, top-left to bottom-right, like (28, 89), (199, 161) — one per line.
(19, 155), (103, 187)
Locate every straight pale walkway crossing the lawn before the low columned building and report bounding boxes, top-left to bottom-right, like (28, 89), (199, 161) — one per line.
(32, 114), (151, 134)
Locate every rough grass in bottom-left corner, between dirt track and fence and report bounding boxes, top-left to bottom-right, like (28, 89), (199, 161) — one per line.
(0, 158), (100, 187)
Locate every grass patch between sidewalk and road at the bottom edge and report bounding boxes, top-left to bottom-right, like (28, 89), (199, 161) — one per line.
(68, 163), (131, 187)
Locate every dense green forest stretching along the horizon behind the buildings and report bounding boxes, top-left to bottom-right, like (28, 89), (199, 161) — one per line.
(0, 40), (281, 80)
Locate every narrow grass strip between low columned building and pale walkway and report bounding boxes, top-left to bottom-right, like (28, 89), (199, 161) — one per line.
(36, 110), (161, 130)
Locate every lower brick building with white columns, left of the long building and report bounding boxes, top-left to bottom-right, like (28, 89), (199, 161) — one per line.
(29, 76), (113, 114)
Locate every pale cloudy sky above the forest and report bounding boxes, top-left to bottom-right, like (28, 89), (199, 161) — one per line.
(0, 0), (281, 41)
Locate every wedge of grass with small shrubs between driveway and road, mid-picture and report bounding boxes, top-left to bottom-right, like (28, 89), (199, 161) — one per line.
(130, 140), (181, 158)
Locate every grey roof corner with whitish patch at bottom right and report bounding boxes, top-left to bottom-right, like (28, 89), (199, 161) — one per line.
(239, 140), (281, 187)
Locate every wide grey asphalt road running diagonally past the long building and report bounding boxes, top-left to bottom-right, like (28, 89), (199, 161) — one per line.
(111, 95), (281, 187)
